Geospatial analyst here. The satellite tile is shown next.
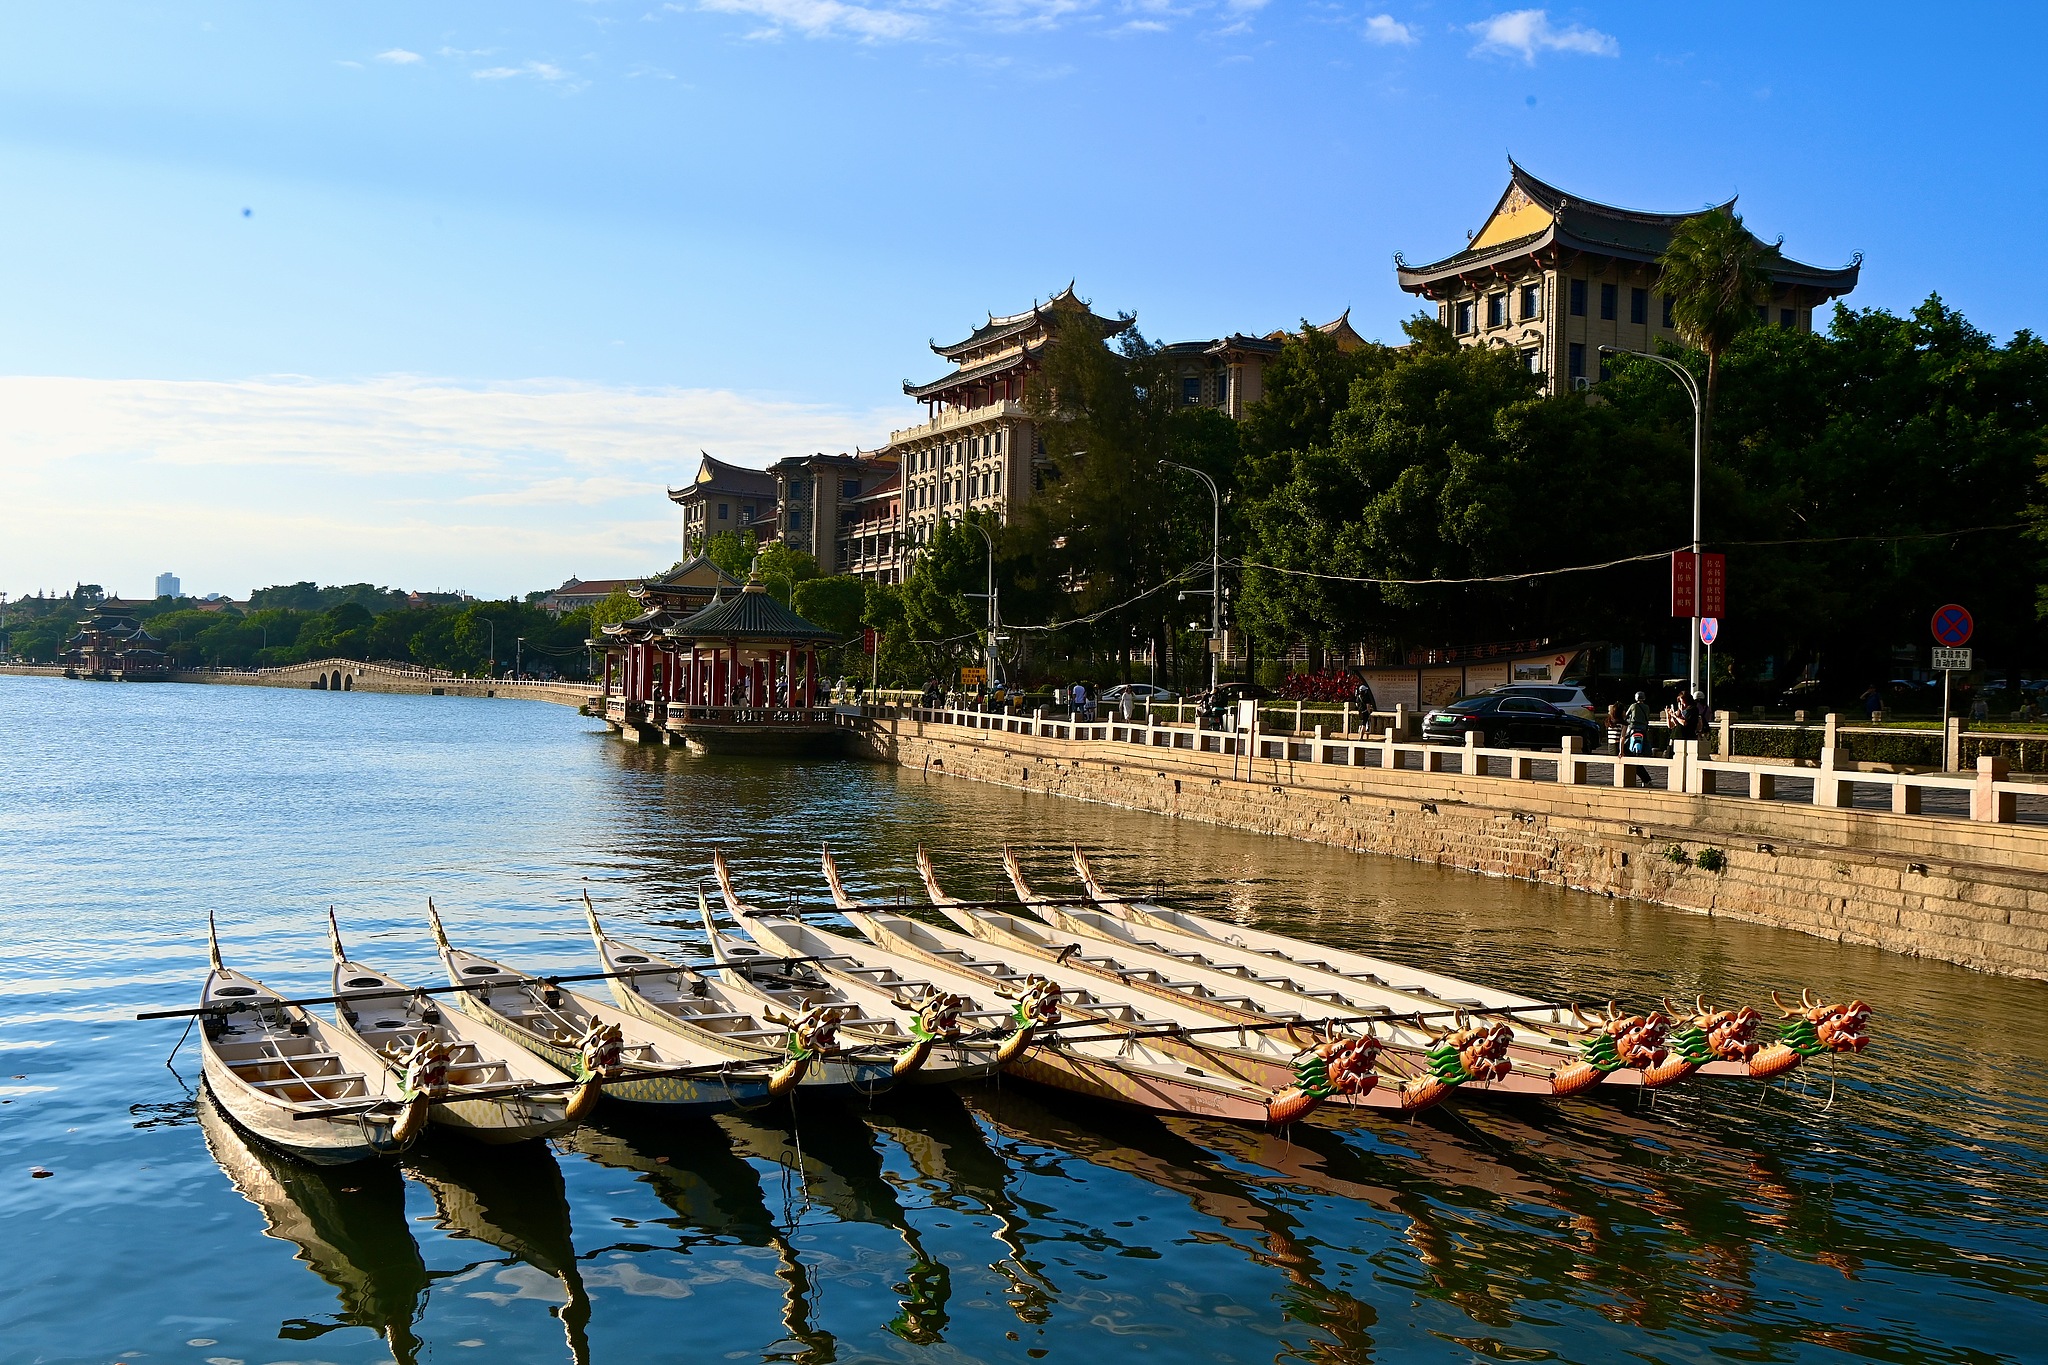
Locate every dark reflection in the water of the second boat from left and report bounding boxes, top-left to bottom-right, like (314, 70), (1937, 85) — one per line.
(406, 1142), (590, 1365)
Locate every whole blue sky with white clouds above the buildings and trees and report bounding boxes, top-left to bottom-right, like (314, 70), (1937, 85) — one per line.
(0, 0), (2048, 598)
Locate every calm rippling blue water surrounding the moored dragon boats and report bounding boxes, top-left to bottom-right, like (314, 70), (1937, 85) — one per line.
(0, 677), (2048, 1365)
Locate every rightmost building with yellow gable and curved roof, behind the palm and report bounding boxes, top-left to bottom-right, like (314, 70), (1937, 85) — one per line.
(1395, 160), (1862, 393)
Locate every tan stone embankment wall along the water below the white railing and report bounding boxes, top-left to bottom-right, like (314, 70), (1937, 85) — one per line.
(860, 716), (2048, 978)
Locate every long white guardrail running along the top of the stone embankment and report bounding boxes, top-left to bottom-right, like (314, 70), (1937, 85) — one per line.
(899, 708), (2048, 825)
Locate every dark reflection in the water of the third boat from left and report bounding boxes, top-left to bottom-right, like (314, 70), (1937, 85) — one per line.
(555, 1109), (840, 1365)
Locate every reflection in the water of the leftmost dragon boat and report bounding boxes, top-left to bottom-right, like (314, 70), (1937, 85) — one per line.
(199, 1089), (426, 1365)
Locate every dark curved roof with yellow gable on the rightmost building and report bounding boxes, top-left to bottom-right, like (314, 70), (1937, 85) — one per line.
(1395, 158), (1862, 299)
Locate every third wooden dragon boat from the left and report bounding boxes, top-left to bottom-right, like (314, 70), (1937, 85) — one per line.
(426, 900), (778, 1113)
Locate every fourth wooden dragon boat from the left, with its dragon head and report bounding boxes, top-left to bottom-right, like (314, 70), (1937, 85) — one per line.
(584, 892), (895, 1095)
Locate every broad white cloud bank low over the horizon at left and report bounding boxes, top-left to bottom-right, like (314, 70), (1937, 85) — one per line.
(0, 377), (903, 596)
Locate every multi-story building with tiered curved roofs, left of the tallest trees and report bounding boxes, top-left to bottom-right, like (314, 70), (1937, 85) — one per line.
(881, 284), (1135, 577)
